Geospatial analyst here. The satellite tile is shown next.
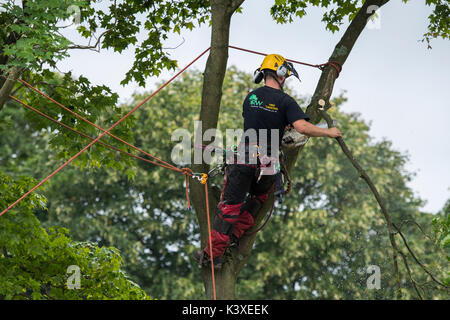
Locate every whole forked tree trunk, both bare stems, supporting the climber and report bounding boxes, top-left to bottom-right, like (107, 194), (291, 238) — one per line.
(191, 0), (390, 299)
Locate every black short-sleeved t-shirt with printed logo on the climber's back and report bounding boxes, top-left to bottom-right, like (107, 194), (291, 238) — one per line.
(242, 86), (309, 154)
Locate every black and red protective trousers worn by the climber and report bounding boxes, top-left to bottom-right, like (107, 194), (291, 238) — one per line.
(204, 164), (275, 258)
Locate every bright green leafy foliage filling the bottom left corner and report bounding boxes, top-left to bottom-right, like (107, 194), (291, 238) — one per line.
(0, 172), (148, 300)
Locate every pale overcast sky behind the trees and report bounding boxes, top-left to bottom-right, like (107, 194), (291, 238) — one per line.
(58, 0), (450, 213)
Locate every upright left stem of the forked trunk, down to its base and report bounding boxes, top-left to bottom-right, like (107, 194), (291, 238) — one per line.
(190, 0), (244, 299)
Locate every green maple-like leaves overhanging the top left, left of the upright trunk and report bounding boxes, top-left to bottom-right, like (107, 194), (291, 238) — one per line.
(0, 0), (210, 86)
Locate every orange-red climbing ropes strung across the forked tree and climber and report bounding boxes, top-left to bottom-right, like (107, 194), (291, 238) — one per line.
(0, 46), (342, 300)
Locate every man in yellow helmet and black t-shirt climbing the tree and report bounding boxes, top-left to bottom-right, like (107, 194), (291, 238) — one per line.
(194, 54), (342, 268)
